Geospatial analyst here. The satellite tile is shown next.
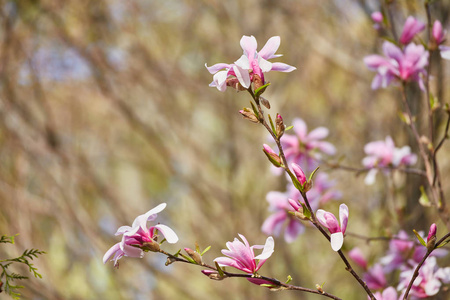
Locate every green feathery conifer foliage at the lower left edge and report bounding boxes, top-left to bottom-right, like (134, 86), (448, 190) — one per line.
(0, 235), (45, 299)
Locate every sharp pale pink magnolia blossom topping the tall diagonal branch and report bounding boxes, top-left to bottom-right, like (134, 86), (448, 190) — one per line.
(205, 35), (296, 92)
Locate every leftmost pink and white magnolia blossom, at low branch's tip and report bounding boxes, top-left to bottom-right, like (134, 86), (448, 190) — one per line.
(103, 203), (178, 266)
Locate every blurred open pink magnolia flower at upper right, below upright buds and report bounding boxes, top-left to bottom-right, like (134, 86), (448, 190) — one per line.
(364, 42), (429, 90)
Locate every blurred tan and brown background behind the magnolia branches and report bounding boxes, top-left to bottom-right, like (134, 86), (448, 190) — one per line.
(0, 0), (450, 299)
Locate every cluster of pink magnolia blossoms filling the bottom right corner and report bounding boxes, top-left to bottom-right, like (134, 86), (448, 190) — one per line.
(349, 224), (450, 300)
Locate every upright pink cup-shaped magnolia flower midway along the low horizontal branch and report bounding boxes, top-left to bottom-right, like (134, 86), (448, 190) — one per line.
(214, 234), (275, 274)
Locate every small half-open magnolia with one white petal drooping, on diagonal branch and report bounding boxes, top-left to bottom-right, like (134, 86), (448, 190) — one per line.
(316, 204), (348, 251)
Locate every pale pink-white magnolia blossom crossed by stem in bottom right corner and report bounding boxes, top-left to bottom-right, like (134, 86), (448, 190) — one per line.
(397, 256), (448, 299)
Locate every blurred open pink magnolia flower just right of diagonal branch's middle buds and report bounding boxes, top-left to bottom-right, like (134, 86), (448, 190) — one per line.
(281, 118), (336, 171)
